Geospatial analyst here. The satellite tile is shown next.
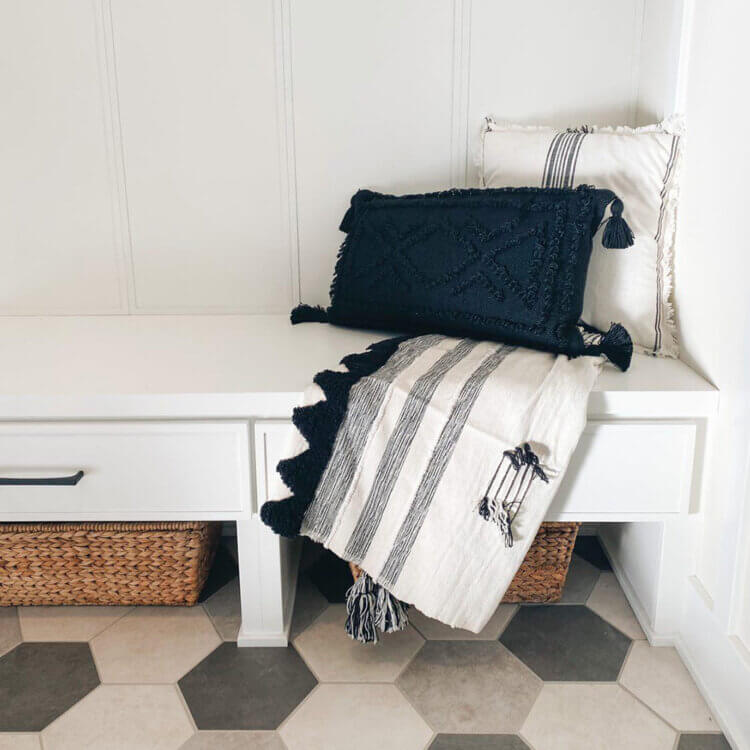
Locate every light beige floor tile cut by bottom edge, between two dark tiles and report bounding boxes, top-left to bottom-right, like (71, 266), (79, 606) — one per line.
(521, 683), (677, 750)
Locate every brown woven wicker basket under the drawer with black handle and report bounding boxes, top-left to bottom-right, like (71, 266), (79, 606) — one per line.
(0, 522), (221, 607)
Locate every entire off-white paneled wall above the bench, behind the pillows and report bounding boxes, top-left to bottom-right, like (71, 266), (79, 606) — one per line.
(0, 0), (680, 314)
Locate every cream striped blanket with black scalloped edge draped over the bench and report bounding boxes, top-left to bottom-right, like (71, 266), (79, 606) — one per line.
(261, 335), (603, 641)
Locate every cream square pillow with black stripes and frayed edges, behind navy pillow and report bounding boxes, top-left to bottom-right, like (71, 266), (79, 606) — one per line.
(480, 117), (684, 357)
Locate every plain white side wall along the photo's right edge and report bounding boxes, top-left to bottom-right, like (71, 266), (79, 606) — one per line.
(675, 0), (750, 748)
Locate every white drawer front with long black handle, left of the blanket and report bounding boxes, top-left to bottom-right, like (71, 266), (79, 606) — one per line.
(0, 420), (250, 520)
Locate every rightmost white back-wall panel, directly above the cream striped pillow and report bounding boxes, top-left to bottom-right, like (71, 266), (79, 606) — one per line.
(469, 0), (645, 187)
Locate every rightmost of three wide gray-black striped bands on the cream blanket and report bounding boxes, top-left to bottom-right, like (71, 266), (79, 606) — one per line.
(378, 346), (515, 588)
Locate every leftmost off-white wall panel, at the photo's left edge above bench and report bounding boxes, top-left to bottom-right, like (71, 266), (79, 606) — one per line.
(0, 0), (127, 314)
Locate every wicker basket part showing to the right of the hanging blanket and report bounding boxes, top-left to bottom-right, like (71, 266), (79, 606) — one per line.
(503, 523), (581, 604)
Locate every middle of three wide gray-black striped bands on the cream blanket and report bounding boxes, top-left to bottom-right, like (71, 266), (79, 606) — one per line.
(344, 339), (478, 563)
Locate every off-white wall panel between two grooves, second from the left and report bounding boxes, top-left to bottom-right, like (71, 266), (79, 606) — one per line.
(112, 0), (293, 312)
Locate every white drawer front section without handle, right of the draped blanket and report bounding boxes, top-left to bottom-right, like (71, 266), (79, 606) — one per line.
(548, 422), (696, 520)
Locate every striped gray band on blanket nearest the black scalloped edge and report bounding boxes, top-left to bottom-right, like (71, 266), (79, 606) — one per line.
(302, 335), (445, 539)
